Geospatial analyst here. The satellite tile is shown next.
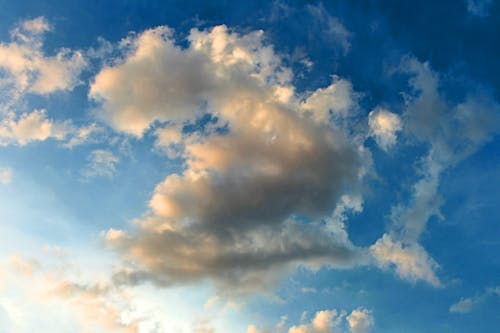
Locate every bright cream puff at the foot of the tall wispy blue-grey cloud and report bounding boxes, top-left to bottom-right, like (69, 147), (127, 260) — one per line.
(370, 234), (441, 287)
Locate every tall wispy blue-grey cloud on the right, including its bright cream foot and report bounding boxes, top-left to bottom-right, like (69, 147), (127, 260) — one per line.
(371, 58), (500, 287)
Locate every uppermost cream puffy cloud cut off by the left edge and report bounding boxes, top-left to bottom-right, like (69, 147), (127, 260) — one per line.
(0, 17), (86, 109)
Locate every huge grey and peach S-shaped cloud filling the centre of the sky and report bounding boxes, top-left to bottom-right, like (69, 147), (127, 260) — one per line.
(94, 26), (365, 292)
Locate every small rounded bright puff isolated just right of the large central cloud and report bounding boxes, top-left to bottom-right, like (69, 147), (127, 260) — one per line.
(368, 108), (402, 151)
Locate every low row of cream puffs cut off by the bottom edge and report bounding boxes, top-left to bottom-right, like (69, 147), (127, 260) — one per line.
(247, 308), (374, 333)
